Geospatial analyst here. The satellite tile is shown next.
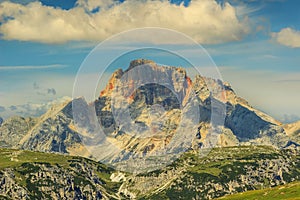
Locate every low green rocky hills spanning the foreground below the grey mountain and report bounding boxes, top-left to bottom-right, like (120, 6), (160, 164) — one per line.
(0, 146), (300, 199)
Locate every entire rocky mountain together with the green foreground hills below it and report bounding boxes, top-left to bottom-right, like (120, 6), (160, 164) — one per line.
(0, 59), (300, 199)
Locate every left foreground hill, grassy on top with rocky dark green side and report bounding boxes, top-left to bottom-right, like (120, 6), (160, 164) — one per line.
(0, 149), (121, 199)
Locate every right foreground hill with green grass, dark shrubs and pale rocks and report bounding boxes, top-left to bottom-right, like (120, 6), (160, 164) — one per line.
(138, 146), (300, 199)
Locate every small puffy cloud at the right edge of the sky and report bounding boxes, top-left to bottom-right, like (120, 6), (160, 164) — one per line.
(272, 28), (300, 48)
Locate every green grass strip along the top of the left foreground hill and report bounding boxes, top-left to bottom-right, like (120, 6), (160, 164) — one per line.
(0, 148), (121, 199)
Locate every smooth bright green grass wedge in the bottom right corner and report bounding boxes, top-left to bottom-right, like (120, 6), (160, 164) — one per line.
(219, 182), (300, 200)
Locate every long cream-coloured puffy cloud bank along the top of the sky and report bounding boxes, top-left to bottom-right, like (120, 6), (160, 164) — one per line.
(0, 0), (249, 44)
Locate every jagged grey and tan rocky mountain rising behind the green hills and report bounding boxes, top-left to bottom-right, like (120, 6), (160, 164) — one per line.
(0, 59), (299, 170)
